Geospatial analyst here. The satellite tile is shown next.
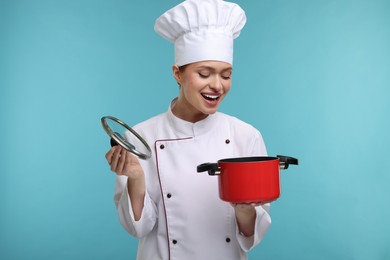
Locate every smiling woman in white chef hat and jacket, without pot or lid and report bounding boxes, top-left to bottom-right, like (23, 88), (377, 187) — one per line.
(106, 0), (271, 260)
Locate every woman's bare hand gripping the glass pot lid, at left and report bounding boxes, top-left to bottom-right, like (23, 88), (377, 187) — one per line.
(106, 145), (144, 180)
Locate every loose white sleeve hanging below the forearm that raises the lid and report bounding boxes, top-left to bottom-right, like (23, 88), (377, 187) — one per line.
(114, 176), (157, 238)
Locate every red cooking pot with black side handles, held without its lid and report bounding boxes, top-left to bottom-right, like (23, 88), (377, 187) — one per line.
(197, 155), (298, 203)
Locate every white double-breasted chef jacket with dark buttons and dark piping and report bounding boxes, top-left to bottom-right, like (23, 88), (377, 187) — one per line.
(114, 99), (271, 260)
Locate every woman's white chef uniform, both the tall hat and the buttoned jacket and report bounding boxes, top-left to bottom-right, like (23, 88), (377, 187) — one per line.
(114, 0), (271, 260)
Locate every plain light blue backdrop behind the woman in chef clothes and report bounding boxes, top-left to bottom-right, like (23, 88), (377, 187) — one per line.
(0, 0), (390, 260)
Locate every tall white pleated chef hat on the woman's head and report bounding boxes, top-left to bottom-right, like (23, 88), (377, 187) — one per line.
(154, 0), (246, 66)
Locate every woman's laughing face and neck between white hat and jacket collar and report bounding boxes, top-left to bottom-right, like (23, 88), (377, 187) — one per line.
(172, 61), (232, 122)
